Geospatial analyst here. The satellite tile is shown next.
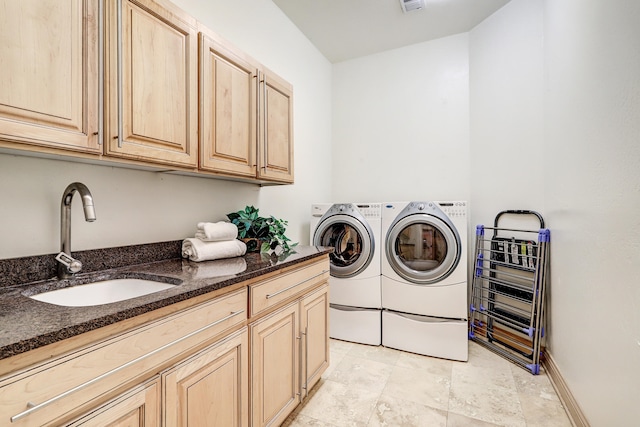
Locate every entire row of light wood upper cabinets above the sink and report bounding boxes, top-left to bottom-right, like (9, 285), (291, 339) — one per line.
(0, 0), (293, 184)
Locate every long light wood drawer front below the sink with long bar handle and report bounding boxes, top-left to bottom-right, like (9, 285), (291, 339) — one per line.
(0, 288), (247, 426)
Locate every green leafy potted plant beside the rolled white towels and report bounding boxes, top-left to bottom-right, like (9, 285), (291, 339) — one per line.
(227, 206), (298, 254)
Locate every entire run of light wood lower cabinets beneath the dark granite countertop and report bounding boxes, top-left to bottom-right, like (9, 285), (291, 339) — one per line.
(0, 257), (329, 427)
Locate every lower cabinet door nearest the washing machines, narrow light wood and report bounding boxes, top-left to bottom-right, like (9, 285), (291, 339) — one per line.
(300, 284), (329, 398)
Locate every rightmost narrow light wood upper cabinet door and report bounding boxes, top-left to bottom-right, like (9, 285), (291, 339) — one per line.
(258, 72), (293, 183)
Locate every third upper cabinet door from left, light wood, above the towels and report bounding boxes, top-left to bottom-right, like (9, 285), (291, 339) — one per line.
(200, 33), (258, 178)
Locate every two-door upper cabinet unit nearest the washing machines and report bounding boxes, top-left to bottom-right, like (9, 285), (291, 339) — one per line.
(200, 30), (293, 183)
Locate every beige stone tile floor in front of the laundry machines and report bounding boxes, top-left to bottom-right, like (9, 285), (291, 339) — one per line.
(283, 340), (571, 427)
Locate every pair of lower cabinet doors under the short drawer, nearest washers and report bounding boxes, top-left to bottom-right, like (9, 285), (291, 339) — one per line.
(249, 283), (329, 427)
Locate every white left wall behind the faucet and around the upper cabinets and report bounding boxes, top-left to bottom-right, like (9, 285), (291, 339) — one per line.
(0, 0), (331, 258)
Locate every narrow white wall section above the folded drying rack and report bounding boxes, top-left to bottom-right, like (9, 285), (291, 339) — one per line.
(469, 0), (545, 225)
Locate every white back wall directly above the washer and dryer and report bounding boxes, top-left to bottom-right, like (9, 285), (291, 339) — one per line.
(332, 34), (469, 202)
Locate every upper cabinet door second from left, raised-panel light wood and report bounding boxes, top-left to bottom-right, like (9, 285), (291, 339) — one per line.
(106, 0), (198, 168)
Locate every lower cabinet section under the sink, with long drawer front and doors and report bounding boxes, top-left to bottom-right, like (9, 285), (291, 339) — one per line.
(0, 288), (248, 427)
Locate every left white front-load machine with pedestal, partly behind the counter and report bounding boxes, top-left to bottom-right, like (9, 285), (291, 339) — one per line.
(310, 203), (382, 345)
